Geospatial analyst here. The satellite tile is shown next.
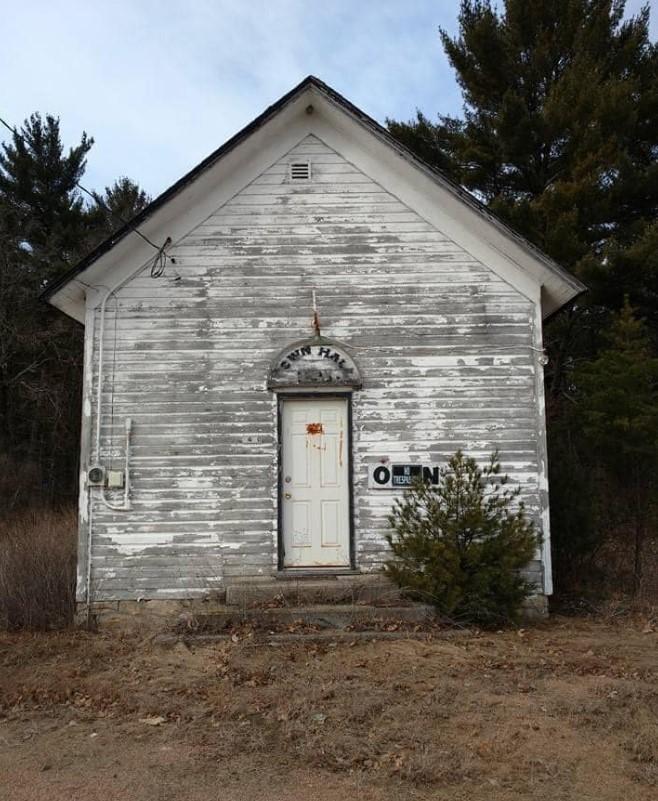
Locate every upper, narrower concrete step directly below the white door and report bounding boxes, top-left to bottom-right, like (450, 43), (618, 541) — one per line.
(226, 574), (400, 609)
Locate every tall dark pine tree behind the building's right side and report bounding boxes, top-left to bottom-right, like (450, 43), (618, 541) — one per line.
(389, 0), (658, 596)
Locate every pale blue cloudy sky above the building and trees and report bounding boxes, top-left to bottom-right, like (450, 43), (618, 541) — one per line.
(0, 0), (658, 196)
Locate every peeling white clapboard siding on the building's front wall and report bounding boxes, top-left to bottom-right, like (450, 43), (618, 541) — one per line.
(79, 135), (548, 600)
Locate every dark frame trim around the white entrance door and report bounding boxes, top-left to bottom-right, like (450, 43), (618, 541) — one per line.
(276, 391), (357, 574)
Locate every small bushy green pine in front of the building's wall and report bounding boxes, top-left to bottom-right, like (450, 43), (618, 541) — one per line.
(385, 451), (540, 625)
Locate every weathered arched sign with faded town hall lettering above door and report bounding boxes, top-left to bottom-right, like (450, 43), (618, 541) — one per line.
(267, 337), (361, 389)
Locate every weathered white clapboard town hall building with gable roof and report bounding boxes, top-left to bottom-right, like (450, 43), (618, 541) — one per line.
(46, 77), (583, 605)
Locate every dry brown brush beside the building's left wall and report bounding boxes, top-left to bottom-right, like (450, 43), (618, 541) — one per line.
(0, 509), (77, 630)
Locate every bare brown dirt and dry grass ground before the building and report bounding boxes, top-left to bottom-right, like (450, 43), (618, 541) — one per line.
(0, 618), (658, 801)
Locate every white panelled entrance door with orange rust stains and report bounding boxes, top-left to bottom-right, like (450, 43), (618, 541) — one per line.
(281, 397), (350, 567)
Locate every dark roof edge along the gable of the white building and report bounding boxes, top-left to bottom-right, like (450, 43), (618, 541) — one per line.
(41, 75), (586, 321)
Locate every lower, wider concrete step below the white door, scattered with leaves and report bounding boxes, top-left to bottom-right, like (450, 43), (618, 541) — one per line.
(182, 604), (434, 633)
